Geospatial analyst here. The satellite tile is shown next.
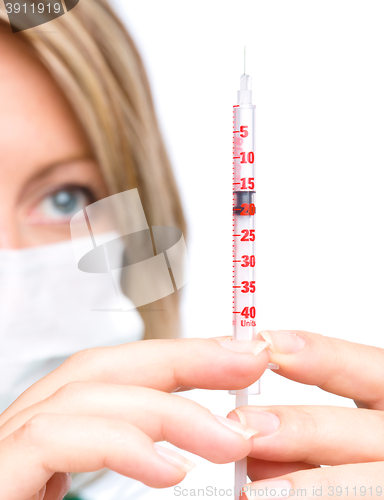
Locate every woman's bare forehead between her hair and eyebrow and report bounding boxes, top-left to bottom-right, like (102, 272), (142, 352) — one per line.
(0, 29), (86, 175)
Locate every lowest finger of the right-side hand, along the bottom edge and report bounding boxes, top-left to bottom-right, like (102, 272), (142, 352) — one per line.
(241, 462), (384, 500)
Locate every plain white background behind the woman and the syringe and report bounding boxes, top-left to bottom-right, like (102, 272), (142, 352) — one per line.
(109, 0), (384, 498)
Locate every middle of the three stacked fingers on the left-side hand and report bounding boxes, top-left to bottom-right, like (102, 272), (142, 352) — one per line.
(0, 382), (257, 463)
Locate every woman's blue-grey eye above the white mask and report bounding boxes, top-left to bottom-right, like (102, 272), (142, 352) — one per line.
(28, 187), (94, 224)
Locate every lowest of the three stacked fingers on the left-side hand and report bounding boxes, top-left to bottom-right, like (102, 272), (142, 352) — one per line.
(0, 413), (196, 500)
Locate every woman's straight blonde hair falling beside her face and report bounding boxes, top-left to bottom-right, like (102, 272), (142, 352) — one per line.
(0, 0), (186, 338)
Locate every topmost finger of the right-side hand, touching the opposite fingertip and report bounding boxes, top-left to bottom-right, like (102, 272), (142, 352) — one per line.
(259, 330), (384, 409)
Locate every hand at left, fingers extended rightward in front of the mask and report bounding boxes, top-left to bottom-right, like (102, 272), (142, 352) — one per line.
(0, 338), (268, 500)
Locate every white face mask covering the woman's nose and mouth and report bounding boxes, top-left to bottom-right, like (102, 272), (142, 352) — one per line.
(0, 236), (144, 411)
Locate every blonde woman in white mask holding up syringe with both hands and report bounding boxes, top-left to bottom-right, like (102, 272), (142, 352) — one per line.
(0, 0), (383, 500)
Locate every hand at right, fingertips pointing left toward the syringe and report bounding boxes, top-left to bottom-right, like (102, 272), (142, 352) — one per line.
(225, 331), (384, 500)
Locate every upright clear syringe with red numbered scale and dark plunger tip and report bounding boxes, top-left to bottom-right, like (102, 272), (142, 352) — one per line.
(229, 72), (260, 500)
